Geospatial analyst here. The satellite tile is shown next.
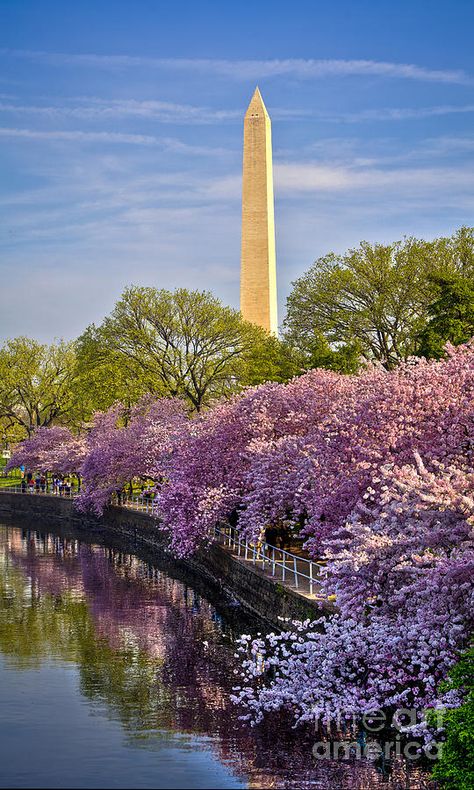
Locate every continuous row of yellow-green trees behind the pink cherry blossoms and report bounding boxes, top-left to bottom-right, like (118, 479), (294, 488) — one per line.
(4, 228), (474, 442)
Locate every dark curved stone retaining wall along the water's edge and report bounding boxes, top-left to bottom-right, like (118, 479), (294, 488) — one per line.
(0, 492), (322, 627)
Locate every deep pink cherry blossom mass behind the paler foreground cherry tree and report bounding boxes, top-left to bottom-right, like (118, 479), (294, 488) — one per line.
(160, 345), (474, 555)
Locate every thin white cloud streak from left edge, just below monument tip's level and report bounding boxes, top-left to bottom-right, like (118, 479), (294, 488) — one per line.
(0, 126), (227, 156)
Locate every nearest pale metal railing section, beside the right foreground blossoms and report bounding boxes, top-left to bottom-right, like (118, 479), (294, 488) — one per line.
(215, 526), (326, 595)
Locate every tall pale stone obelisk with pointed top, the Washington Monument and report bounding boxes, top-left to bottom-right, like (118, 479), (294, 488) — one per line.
(240, 88), (278, 335)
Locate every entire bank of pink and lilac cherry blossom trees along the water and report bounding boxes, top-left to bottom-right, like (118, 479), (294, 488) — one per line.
(11, 342), (474, 740)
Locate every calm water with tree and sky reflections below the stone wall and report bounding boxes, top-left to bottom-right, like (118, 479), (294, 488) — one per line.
(0, 524), (436, 790)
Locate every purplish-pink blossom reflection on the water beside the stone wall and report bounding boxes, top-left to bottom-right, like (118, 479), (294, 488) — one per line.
(0, 528), (434, 790)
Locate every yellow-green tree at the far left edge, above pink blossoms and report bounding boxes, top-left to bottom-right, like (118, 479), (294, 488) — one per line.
(0, 337), (75, 438)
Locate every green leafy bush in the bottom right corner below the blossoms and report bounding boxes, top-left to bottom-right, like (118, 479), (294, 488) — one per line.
(428, 648), (474, 790)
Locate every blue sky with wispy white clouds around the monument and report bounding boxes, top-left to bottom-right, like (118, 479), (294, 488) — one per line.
(0, 0), (474, 340)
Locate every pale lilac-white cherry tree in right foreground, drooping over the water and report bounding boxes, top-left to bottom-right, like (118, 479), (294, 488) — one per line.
(235, 455), (474, 722)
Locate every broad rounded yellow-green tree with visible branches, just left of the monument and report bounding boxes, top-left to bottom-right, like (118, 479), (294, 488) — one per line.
(77, 287), (297, 411)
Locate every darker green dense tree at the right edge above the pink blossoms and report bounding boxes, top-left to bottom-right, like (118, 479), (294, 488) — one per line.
(418, 275), (474, 359)
